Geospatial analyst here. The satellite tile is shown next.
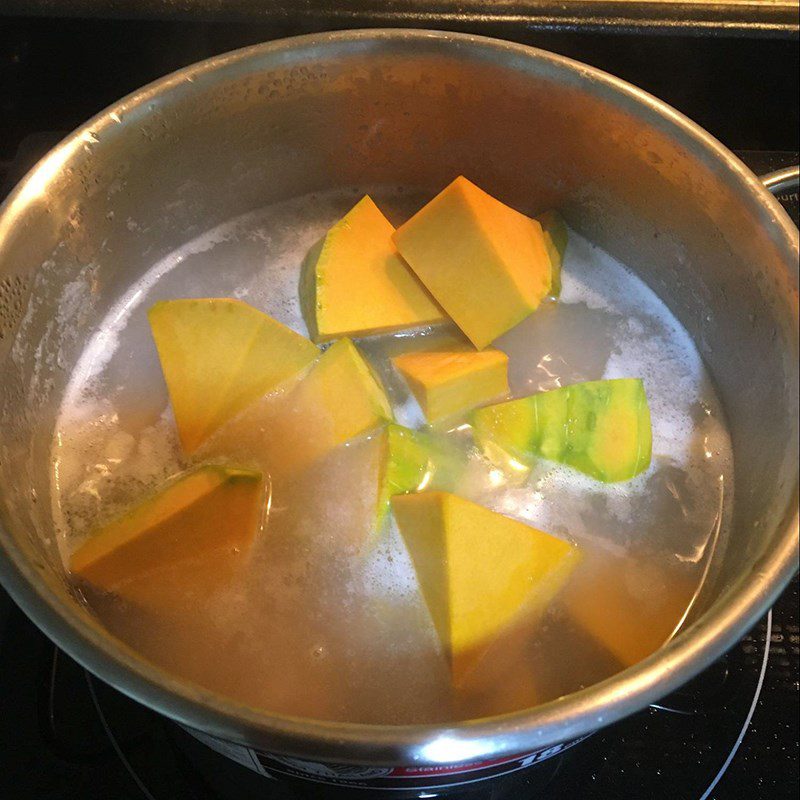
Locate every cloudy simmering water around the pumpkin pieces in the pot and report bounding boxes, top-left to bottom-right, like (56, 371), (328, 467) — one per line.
(52, 189), (733, 723)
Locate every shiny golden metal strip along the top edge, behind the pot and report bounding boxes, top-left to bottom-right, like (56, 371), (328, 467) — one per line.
(0, 0), (798, 37)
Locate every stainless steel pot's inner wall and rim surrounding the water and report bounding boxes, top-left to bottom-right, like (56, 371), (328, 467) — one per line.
(0, 30), (798, 788)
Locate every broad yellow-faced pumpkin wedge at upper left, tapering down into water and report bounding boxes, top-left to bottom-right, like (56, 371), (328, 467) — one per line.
(148, 298), (319, 454)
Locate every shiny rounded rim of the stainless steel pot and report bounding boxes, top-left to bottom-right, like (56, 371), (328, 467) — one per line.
(0, 29), (798, 765)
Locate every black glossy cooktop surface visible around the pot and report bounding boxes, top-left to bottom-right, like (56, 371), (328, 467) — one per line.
(0, 12), (800, 800)
